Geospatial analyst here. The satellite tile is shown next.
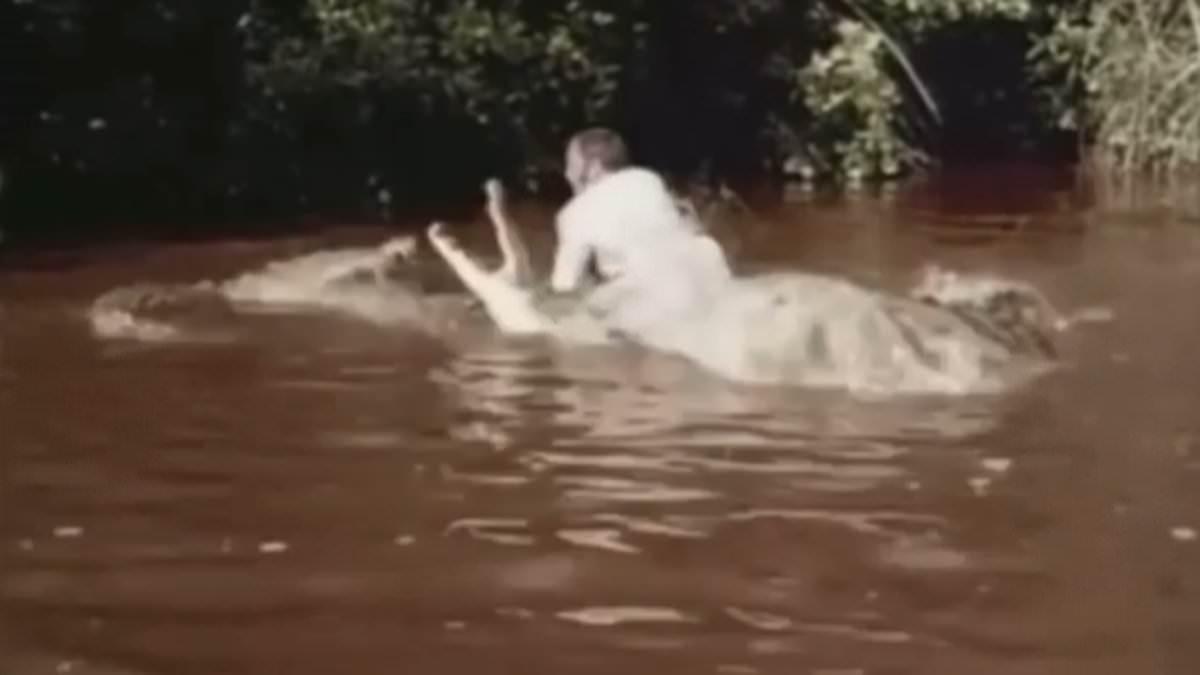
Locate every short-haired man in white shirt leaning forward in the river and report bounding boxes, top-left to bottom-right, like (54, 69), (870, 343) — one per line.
(551, 127), (732, 342)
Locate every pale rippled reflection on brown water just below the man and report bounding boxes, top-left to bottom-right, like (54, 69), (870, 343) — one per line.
(432, 336), (1004, 521)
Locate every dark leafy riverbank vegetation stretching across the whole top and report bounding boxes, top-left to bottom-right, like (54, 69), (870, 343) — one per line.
(0, 0), (1200, 239)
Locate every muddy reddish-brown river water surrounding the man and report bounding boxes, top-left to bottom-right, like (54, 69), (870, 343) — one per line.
(0, 164), (1200, 675)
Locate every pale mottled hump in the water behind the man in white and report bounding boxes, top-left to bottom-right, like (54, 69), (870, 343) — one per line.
(609, 264), (1057, 395)
